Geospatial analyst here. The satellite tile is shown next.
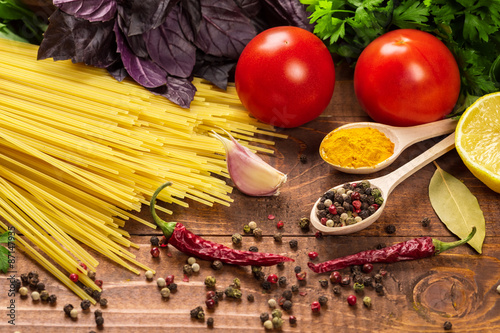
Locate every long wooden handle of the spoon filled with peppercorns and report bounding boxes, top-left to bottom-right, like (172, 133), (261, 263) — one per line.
(371, 133), (455, 198)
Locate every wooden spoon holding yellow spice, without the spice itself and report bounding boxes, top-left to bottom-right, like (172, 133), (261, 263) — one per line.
(319, 119), (457, 174)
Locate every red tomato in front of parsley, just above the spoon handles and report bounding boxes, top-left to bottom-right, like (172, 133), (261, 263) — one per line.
(354, 29), (460, 126)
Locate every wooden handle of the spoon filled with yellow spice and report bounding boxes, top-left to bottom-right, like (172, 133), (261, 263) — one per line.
(394, 118), (457, 150)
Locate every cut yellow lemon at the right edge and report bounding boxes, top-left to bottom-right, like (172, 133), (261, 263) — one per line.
(455, 92), (500, 193)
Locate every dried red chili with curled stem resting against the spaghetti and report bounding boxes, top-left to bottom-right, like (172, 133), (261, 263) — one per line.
(150, 182), (295, 266)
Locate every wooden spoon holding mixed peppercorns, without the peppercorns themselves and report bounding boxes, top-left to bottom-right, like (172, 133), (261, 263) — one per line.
(310, 133), (455, 235)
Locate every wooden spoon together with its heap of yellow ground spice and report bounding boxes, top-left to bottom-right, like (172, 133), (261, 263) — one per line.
(319, 119), (457, 174)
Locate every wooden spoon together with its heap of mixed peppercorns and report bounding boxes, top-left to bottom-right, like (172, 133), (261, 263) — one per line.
(310, 133), (455, 235)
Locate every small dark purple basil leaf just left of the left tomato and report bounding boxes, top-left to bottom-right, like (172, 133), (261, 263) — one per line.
(193, 52), (236, 90)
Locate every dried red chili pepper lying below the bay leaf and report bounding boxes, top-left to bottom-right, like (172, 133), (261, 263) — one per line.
(307, 227), (476, 273)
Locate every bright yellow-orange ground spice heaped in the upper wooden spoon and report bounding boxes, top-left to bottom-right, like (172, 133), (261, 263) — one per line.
(320, 127), (394, 168)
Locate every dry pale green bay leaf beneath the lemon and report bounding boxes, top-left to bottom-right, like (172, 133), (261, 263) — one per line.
(429, 163), (485, 253)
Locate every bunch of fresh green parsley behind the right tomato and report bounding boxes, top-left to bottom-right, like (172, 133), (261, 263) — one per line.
(300, 0), (500, 115)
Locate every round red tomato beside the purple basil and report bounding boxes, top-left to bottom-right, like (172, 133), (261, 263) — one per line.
(235, 26), (335, 128)
